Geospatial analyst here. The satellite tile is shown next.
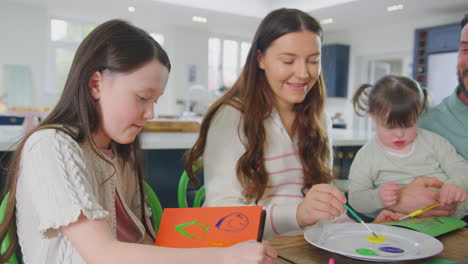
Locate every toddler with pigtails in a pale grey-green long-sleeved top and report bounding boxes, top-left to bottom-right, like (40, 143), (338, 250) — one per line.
(349, 75), (468, 217)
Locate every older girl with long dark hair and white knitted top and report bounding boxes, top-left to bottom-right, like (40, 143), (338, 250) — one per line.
(0, 20), (276, 263)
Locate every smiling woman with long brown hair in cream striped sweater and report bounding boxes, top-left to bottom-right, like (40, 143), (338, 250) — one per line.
(185, 9), (352, 237)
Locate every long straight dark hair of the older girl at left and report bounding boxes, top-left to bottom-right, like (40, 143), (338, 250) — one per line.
(0, 20), (171, 263)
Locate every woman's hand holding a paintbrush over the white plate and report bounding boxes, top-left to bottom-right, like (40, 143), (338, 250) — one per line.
(296, 184), (346, 227)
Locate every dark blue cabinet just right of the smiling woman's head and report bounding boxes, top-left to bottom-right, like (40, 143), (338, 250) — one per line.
(322, 44), (349, 97)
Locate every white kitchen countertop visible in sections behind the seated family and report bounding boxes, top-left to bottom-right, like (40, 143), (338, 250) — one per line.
(0, 126), (369, 151)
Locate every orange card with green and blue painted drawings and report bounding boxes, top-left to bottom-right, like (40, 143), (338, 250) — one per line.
(156, 206), (265, 248)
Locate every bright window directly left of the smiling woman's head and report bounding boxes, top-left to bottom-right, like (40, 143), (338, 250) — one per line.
(208, 37), (251, 90)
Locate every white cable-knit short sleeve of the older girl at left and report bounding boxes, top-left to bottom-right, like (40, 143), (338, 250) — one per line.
(18, 129), (108, 237)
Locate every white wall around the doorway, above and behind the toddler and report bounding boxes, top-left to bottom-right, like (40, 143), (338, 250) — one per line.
(324, 10), (468, 131)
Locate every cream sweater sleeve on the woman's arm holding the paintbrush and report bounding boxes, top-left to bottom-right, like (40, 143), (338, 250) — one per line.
(203, 106), (300, 239)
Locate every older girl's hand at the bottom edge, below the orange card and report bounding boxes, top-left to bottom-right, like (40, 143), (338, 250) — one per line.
(222, 240), (278, 264)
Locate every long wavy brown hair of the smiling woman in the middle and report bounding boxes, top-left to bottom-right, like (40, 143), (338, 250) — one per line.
(185, 8), (331, 202)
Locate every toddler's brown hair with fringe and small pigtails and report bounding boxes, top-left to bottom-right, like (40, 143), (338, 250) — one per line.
(353, 75), (429, 128)
